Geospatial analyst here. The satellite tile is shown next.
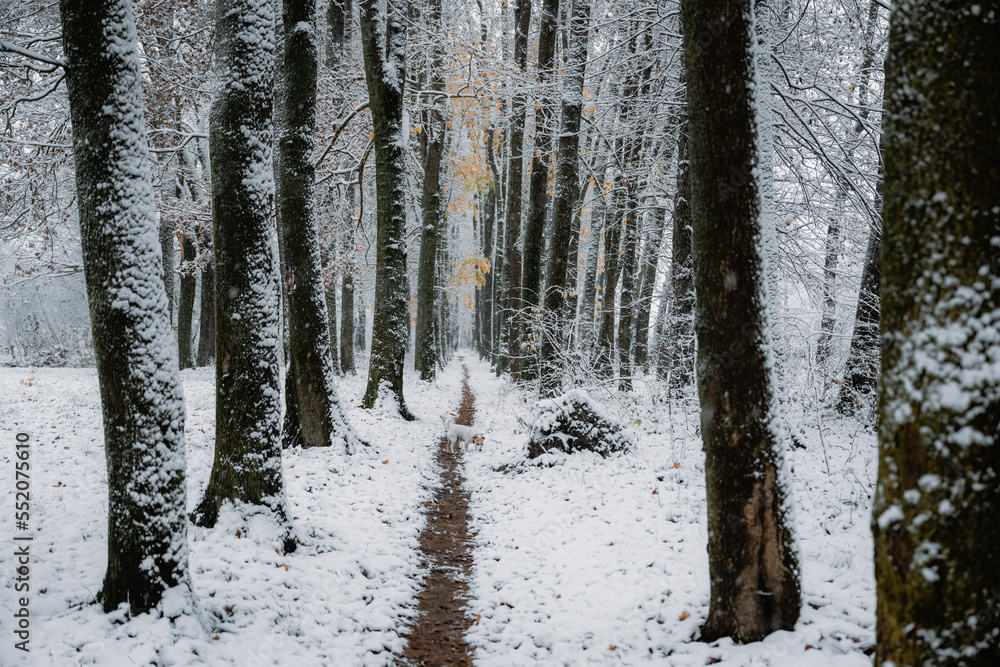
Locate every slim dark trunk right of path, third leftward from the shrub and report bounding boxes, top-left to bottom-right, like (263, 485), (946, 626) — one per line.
(497, 0), (531, 379)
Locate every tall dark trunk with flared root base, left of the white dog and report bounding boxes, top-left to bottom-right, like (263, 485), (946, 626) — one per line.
(360, 0), (414, 420)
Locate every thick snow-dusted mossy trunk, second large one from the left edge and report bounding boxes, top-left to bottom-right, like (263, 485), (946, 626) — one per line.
(192, 0), (295, 551)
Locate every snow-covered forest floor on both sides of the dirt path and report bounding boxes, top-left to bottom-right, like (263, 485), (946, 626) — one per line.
(0, 353), (876, 667)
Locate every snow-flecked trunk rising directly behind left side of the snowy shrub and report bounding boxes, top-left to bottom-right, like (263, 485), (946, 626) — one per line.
(540, 0), (590, 398)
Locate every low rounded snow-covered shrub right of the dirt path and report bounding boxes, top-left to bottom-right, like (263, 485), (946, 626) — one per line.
(528, 389), (634, 459)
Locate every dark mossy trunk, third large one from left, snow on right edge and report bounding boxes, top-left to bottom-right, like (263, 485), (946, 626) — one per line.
(278, 0), (357, 452)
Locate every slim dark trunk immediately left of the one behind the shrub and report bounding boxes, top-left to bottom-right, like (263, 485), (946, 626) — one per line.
(517, 0), (560, 380)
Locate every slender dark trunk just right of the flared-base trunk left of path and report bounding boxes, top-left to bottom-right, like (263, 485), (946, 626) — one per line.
(413, 0), (447, 380)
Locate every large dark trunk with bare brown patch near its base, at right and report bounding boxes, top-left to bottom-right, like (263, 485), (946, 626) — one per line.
(681, 0), (801, 642)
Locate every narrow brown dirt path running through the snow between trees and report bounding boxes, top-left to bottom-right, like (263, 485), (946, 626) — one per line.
(403, 366), (476, 667)
